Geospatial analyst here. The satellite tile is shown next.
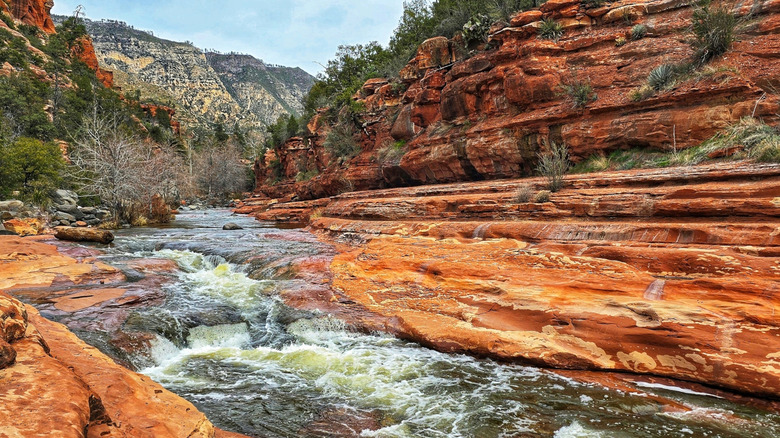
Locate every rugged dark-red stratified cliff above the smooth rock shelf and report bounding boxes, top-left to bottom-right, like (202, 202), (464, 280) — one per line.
(256, 0), (780, 200)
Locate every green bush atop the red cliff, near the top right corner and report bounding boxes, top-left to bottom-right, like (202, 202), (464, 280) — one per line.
(692, 1), (737, 64)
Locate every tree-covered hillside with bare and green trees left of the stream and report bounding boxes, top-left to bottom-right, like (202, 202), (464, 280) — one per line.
(0, 13), (247, 225)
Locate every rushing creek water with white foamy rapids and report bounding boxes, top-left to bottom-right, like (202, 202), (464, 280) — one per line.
(47, 210), (780, 438)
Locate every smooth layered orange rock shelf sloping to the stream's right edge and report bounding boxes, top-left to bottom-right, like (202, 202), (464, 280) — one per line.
(290, 163), (780, 398)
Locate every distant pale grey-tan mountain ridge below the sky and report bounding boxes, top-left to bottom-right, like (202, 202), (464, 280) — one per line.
(63, 17), (313, 127)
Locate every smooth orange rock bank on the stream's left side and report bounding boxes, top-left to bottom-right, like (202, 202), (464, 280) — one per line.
(0, 236), (242, 438)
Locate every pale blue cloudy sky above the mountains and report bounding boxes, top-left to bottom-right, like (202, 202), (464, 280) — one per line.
(52, 0), (403, 74)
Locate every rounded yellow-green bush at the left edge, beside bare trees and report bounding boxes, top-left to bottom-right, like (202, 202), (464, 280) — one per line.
(0, 137), (64, 204)
